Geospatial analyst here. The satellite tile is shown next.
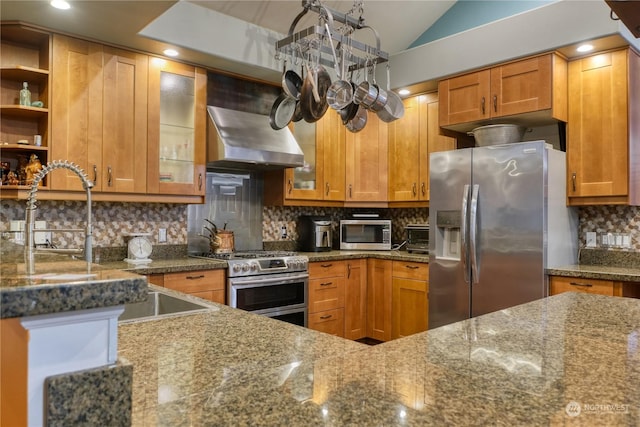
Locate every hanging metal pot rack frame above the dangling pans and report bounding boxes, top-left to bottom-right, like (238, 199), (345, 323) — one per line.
(275, 0), (389, 73)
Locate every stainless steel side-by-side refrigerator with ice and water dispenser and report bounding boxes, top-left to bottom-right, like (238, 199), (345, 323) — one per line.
(429, 141), (578, 329)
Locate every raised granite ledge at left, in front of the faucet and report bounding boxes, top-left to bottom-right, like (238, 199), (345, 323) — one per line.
(0, 256), (147, 319)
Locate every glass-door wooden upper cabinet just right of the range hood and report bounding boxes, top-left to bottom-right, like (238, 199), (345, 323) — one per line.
(264, 110), (346, 206)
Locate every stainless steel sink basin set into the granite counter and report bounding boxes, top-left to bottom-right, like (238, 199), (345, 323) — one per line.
(118, 292), (214, 322)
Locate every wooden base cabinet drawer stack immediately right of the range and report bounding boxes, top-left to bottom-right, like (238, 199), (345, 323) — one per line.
(308, 261), (346, 337)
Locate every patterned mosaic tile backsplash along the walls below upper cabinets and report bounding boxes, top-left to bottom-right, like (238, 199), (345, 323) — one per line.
(0, 200), (640, 252)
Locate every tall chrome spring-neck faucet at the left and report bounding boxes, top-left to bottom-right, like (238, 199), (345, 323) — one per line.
(24, 160), (93, 274)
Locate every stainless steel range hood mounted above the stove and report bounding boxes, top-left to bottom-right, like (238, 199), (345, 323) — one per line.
(207, 106), (304, 170)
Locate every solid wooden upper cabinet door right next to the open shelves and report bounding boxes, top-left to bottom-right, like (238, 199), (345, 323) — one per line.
(50, 34), (104, 191)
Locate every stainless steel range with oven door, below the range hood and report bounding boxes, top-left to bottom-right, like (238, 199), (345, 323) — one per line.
(192, 251), (309, 326)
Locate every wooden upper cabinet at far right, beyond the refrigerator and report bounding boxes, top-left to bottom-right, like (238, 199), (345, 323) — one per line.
(567, 49), (640, 206)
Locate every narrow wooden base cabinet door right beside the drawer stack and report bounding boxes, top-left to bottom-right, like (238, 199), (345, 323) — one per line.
(344, 258), (367, 340)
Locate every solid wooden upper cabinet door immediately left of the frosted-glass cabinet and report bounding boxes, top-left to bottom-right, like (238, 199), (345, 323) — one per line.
(100, 46), (148, 193)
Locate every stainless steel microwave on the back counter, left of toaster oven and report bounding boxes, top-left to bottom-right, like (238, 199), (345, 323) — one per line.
(340, 219), (391, 251)
